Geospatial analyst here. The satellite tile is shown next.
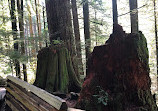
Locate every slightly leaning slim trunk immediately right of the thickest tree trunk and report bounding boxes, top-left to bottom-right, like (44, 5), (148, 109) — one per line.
(71, 0), (84, 75)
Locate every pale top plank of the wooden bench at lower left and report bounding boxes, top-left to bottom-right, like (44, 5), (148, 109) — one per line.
(7, 76), (68, 110)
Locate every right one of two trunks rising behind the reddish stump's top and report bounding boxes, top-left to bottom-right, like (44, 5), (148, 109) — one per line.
(129, 0), (139, 33)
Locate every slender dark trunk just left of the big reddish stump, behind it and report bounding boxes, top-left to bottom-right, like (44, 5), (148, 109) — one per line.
(83, 0), (91, 74)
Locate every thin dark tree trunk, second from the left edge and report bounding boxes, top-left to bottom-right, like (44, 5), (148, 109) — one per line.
(17, 0), (27, 81)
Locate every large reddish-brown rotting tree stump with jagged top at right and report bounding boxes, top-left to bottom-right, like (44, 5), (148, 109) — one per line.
(78, 25), (157, 111)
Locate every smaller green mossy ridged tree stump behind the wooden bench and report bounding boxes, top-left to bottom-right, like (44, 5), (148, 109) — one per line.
(34, 45), (81, 93)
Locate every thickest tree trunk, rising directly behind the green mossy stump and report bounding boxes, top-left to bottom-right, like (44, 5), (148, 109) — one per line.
(46, 0), (73, 46)
